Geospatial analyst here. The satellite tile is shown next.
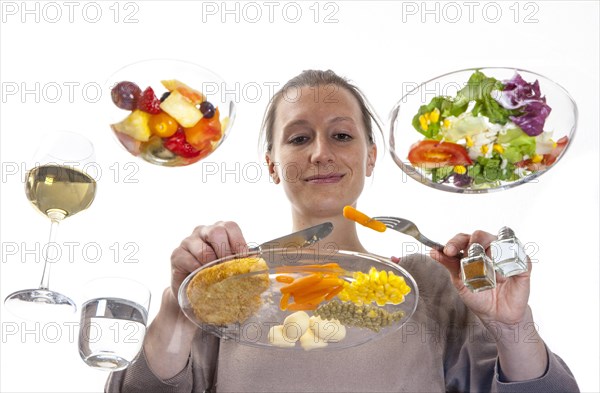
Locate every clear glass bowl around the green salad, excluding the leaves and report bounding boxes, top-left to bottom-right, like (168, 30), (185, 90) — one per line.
(389, 67), (578, 194)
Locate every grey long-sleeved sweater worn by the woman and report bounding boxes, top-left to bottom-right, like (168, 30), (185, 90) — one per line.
(106, 255), (579, 393)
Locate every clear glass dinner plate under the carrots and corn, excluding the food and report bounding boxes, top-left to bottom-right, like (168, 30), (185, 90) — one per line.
(179, 248), (419, 351)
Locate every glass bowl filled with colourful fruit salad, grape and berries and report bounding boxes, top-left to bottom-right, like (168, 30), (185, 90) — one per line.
(106, 59), (236, 167)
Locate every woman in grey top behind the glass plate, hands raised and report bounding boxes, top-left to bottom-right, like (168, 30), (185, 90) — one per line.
(106, 71), (578, 392)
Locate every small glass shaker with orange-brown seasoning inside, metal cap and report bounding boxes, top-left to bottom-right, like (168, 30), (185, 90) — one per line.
(460, 243), (496, 292)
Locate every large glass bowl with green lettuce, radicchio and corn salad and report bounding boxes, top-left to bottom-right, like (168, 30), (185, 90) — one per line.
(390, 68), (577, 194)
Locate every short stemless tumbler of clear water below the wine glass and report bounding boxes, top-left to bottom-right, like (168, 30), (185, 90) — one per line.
(79, 277), (150, 371)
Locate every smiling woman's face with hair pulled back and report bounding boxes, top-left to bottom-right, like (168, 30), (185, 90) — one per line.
(267, 85), (377, 217)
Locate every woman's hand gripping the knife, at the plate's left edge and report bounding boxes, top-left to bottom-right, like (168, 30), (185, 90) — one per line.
(171, 221), (248, 299)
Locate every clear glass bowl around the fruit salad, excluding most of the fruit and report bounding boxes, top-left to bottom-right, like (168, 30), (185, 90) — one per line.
(103, 59), (236, 167)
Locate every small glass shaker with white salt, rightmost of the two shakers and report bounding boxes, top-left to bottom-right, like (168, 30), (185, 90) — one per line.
(490, 227), (528, 277)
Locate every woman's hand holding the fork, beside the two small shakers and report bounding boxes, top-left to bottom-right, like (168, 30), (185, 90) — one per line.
(431, 231), (531, 325)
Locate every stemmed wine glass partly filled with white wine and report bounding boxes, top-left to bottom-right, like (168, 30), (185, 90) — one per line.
(4, 131), (96, 320)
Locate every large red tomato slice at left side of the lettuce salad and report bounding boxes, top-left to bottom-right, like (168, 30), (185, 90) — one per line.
(408, 139), (473, 169)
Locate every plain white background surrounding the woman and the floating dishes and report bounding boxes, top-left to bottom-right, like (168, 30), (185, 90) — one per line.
(0, 1), (600, 392)
